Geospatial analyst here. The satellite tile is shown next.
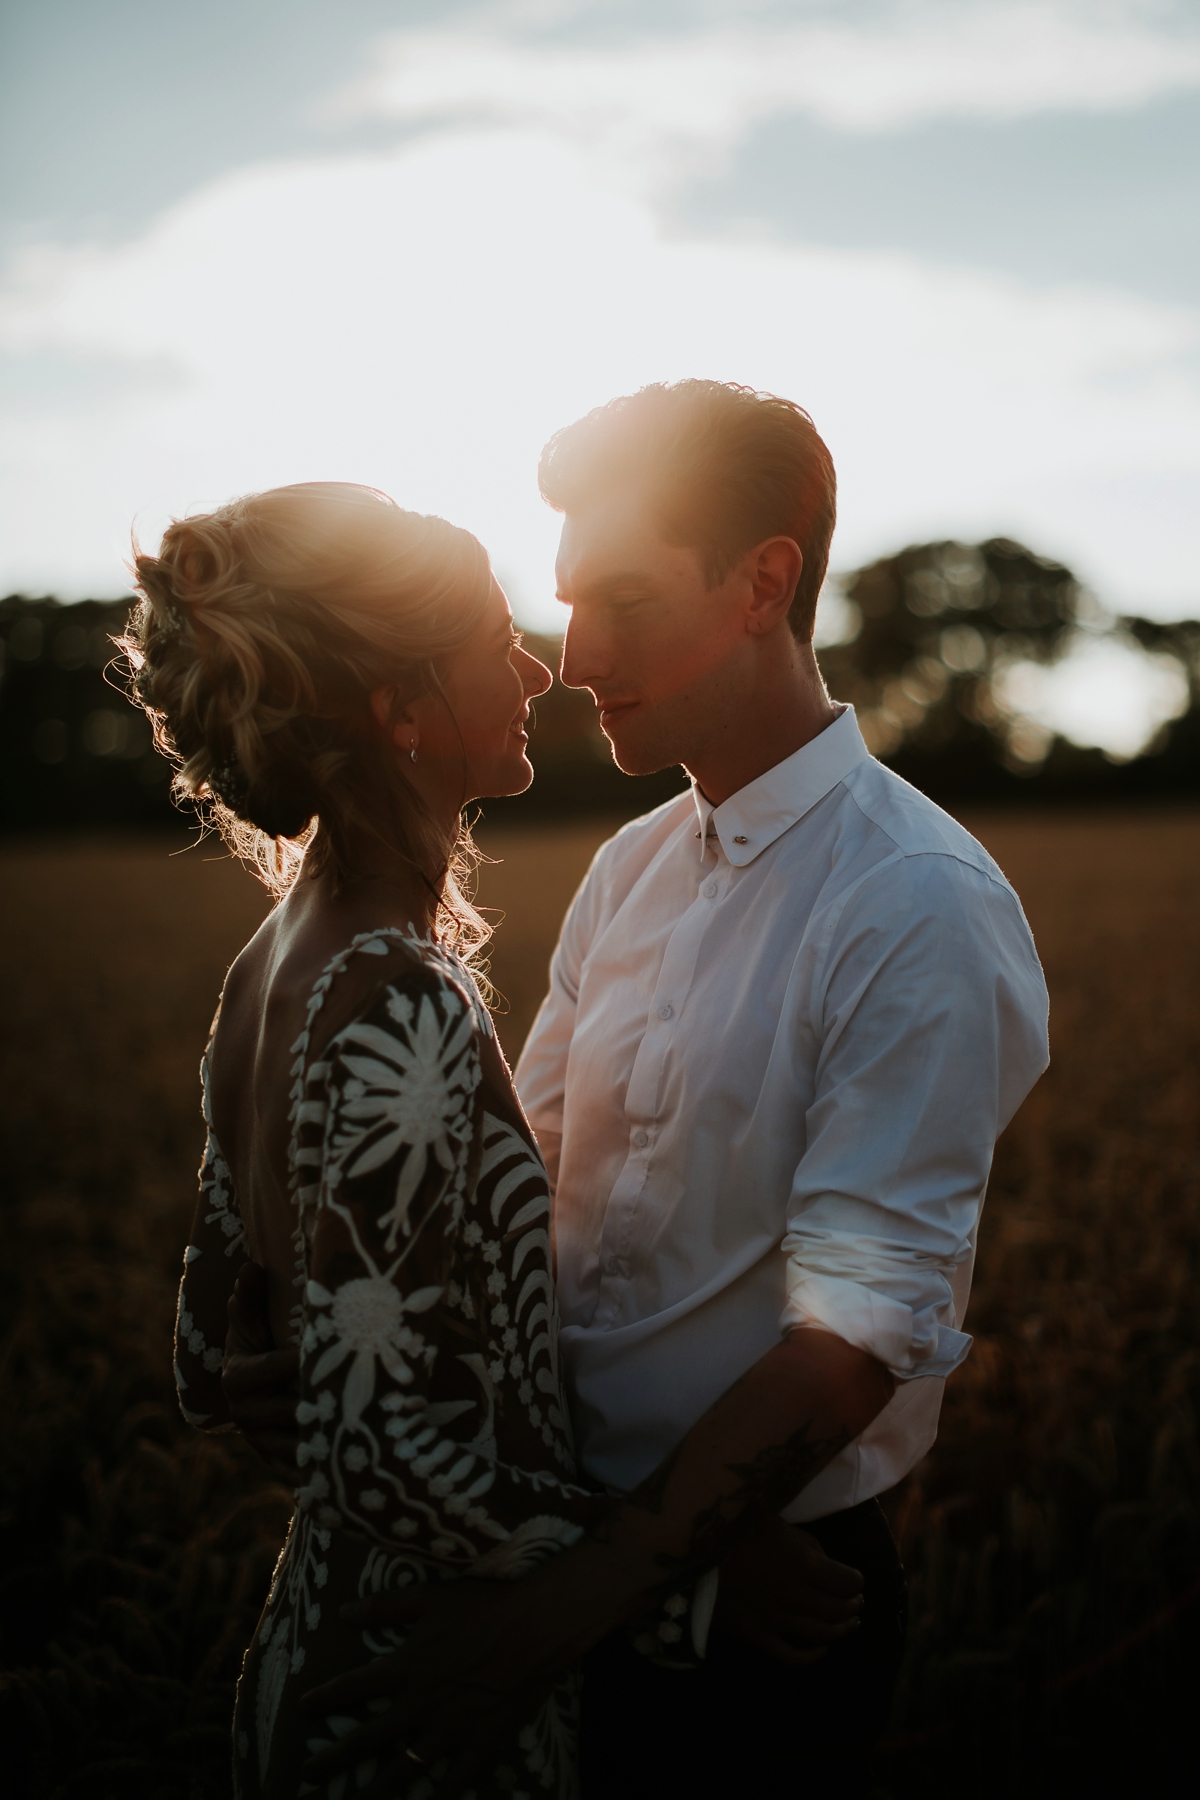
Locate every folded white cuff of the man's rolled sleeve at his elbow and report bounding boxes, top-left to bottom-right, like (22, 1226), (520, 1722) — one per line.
(779, 1262), (972, 1381)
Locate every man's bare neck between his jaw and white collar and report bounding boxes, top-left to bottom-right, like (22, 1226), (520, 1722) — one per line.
(684, 644), (838, 806)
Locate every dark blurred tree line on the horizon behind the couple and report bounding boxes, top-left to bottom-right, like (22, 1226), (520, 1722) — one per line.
(0, 538), (1200, 833)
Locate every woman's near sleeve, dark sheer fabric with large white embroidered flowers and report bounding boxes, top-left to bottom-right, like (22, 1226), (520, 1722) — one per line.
(295, 967), (596, 1575)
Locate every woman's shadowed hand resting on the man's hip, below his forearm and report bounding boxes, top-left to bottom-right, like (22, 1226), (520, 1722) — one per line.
(714, 1517), (864, 1665)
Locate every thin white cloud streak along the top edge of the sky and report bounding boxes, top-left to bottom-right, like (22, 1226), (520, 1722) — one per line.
(324, 0), (1200, 180)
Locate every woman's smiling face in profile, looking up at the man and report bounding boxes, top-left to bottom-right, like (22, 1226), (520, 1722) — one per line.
(399, 580), (554, 810)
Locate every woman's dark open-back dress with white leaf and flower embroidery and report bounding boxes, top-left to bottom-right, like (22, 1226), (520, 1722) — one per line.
(176, 931), (604, 1800)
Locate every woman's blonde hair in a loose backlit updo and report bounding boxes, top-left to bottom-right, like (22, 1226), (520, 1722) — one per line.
(119, 482), (493, 950)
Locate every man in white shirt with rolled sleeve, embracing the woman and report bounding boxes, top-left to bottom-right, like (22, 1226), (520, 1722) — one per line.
(227, 382), (1047, 1800)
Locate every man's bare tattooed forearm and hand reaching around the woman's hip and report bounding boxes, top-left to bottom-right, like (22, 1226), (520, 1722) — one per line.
(298, 1330), (892, 1795)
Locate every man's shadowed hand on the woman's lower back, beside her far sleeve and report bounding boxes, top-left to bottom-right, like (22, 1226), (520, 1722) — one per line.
(221, 1262), (300, 1487)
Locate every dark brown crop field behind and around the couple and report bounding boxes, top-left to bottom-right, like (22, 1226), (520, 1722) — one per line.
(0, 812), (1200, 1800)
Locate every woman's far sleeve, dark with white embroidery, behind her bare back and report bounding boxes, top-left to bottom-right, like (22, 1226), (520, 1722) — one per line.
(175, 1055), (250, 1431)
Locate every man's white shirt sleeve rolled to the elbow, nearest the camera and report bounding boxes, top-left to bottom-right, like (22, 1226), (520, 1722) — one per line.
(781, 853), (1049, 1381)
